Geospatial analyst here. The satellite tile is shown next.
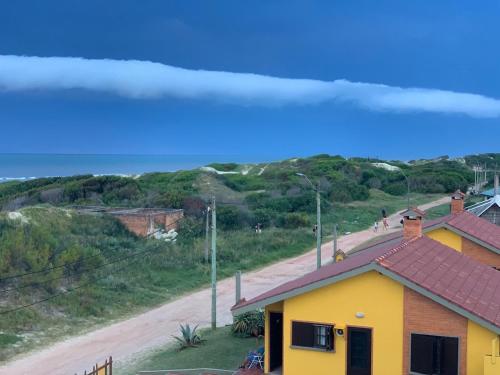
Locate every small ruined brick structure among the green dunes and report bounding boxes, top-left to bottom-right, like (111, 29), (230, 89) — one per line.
(110, 208), (184, 237)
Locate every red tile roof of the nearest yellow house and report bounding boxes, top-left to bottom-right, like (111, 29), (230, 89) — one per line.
(232, 236), (500, 328)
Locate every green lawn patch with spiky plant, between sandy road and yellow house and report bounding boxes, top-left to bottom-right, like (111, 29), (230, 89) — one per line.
(116, 327), (263, 375)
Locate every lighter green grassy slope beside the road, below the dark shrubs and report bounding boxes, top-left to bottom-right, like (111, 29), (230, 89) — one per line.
(0, 207), (314, 360)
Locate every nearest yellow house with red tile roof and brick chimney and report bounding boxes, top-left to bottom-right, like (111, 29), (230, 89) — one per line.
(232, 210), (500, 375)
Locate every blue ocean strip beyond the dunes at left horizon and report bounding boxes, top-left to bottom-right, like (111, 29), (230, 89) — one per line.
(0, 154), (271, 182)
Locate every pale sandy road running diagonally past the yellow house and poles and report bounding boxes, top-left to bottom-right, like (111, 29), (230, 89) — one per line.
(0, 198), (449, 375)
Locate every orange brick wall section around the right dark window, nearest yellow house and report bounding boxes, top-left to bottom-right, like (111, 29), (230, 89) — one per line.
(403, 287), (467, 375)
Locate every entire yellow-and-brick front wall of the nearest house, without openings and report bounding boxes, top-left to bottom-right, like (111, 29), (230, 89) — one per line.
(265, 271), (500, 375)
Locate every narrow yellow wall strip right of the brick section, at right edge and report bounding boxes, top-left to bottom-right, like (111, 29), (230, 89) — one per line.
(467, 320), (500, 375)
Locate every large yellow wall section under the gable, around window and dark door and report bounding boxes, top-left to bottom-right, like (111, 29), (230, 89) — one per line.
(280, 271), (403, 375)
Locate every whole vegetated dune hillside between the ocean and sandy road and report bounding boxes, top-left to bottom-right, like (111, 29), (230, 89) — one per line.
(0, 155), (488, 360)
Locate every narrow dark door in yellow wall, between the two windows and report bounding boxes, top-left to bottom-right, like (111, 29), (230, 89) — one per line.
(347, 327), (372, 375)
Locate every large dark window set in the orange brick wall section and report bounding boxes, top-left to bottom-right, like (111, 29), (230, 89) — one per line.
(410, 333), (458, 375)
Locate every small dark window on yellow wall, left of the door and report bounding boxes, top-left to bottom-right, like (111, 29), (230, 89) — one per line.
(292, 322), (334, 351)
